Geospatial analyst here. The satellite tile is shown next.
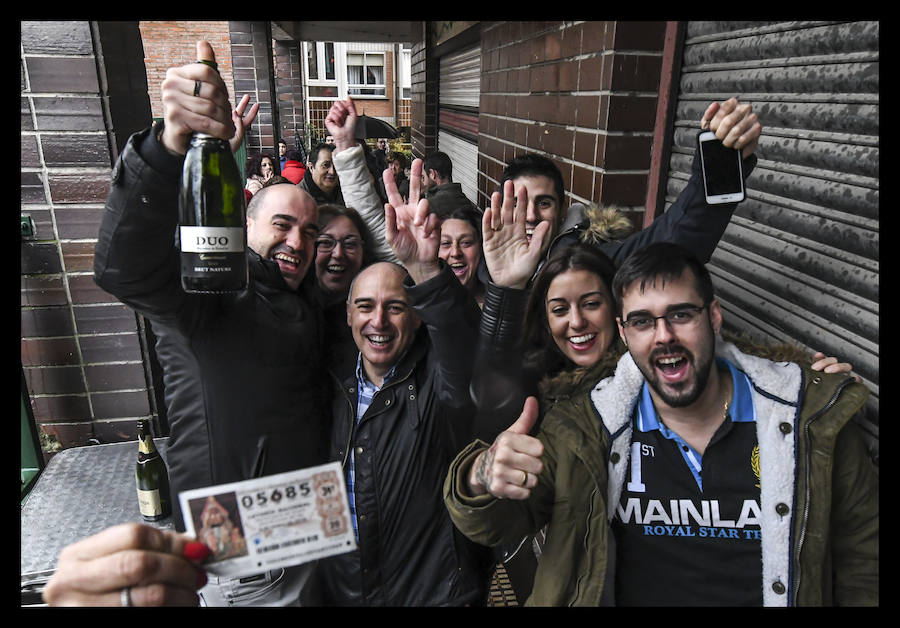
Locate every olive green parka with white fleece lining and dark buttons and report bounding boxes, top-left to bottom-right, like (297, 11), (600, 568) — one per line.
(444, 341), (878, 606)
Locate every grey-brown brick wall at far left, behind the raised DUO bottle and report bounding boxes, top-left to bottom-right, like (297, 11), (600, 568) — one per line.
(20, 21), (150, 457)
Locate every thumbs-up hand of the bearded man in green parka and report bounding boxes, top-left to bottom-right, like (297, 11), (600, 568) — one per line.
(469, 397), (544, 499)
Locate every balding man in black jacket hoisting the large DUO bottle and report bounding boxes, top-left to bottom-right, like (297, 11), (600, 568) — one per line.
(82, 41), (330, 606)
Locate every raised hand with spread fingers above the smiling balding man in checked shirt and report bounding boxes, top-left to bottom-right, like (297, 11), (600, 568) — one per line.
(383, 159), (441, 283)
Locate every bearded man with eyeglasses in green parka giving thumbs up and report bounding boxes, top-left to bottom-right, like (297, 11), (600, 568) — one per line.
(444, 243), (878, 606)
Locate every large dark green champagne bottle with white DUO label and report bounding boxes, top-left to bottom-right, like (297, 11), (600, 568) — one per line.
(178, 61), (247, 293)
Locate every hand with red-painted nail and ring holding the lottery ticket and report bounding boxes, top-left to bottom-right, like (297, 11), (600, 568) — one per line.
(44, 523), (210, 606)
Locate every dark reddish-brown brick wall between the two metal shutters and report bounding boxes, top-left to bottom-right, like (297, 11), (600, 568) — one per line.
(478, 21), (665, 224)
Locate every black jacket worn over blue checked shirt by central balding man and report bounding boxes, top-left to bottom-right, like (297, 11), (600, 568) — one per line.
(319, 265), (489, 606)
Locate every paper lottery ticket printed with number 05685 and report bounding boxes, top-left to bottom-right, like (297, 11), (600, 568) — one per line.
(178, 462), (356, 576)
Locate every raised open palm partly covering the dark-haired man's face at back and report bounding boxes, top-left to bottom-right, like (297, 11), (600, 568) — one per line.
(481, 181), (550, 288)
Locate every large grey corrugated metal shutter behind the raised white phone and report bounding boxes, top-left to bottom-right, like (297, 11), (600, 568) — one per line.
(666, 22), (879, 456)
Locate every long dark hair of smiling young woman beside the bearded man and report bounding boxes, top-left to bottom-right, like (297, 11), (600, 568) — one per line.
(525, 242), (616, 375)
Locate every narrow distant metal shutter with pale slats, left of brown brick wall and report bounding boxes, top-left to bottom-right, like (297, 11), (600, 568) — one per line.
(438, 45), (481, 202)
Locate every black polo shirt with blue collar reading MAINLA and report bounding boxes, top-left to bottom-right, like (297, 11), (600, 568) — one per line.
(613, 359), (762, 606)
